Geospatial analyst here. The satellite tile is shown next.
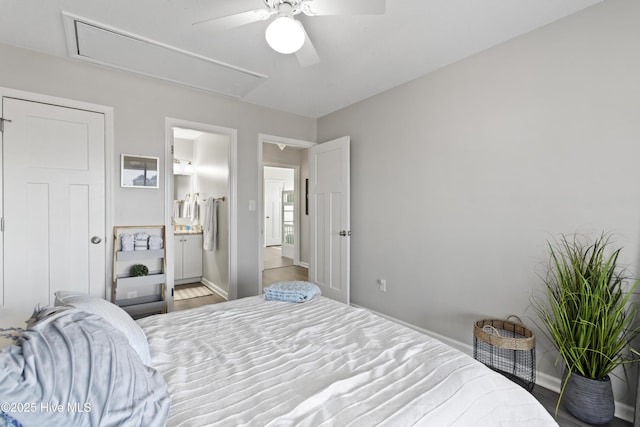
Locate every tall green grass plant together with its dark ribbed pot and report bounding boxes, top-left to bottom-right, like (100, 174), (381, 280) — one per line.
(534, 233), (640, 424)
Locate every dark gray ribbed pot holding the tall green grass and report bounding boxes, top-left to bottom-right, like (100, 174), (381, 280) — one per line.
(562, 372), (616, 424)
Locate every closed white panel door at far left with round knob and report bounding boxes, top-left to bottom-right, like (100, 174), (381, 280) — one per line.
(2, 97), (106, 314)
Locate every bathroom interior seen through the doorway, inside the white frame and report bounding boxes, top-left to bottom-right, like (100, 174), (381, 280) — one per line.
(173, 127), (230, 310)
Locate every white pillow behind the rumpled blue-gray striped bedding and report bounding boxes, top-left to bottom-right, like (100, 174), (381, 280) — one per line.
(55, 291), (151, 365)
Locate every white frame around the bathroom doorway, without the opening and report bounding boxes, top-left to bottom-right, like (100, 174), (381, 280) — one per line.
(164, 117), (238, 311)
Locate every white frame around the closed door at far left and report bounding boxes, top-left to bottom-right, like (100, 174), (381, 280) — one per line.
(0, 87), (115, 305)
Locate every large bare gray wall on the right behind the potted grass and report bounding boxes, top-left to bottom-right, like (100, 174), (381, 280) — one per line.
(318, 0), (640, 410)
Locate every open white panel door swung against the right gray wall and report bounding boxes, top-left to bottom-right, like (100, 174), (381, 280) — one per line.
(309, 136), (351, 304)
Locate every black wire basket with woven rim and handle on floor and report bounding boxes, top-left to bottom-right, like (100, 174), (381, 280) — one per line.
(473, 316), (536, 391)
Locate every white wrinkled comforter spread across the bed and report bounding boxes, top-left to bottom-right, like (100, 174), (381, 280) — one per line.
(138, 297), (556, 427)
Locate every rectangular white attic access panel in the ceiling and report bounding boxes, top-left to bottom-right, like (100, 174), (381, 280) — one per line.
(63, 13), (267, 98)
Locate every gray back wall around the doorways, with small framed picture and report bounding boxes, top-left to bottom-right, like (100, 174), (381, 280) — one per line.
(0, 44), (316, 297)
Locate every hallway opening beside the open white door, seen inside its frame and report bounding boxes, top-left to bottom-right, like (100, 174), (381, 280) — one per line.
(259, 135), (313, 290)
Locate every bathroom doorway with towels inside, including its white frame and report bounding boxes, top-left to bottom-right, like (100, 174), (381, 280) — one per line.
(167, 119), (237, 310)
